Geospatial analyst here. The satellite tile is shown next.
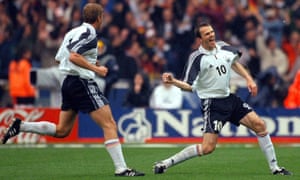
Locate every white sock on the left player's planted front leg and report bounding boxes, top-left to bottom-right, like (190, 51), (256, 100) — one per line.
(104, 139), (127, 173)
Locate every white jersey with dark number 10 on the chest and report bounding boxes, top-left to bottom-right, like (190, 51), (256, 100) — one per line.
(183, 41), (240, 99)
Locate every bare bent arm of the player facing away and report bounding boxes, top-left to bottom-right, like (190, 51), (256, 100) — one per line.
(69, 52), (108, 76)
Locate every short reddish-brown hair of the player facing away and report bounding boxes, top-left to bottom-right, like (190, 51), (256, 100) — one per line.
(82, 3), (103, 23)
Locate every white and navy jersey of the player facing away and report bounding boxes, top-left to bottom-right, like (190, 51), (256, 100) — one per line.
(55, 23), (98, 79)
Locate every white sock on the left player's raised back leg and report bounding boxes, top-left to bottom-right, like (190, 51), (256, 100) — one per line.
(20, 121), (56, 136)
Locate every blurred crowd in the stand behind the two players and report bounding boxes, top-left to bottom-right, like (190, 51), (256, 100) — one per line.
(0, 0), (300, 109)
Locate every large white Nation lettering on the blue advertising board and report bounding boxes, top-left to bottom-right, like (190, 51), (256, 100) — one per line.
(153, 110), (300, 137)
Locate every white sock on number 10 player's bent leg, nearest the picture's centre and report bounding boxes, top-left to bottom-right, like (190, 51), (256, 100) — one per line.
(162, 144), (203, 168)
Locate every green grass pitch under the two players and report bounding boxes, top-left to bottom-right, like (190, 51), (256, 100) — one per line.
(0, 145), (300, 180)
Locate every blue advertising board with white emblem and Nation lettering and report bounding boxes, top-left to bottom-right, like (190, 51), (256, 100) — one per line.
(79, 108), (300, 143)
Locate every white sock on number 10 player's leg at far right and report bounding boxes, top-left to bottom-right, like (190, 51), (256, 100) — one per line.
(257, 134), (279, 172)
